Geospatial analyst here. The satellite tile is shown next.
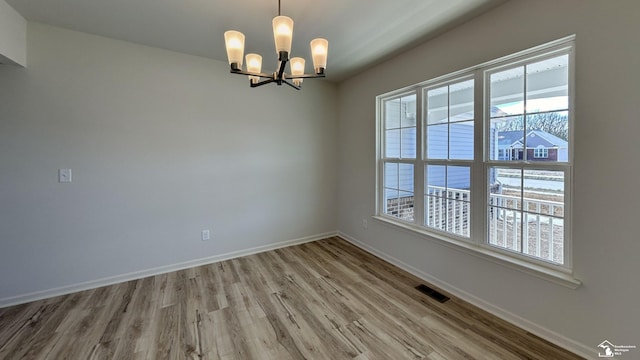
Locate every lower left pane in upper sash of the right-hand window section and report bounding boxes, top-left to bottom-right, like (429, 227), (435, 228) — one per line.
(489, 116), (524, 161)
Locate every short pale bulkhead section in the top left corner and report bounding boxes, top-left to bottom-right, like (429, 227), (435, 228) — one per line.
(0, 0), (27, 66)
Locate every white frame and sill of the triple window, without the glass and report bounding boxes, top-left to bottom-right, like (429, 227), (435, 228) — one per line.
(374, 35), (581, 289)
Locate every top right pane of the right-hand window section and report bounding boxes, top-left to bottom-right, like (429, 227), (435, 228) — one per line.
(526, 55), (569, 113)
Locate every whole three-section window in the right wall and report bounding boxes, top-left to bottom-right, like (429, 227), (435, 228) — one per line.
(377, 37), (573, 273)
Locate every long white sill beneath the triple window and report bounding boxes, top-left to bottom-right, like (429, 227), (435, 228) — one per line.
(373, 216), (582, 289)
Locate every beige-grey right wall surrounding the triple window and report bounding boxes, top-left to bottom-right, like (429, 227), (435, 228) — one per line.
(339, 0), (640, 358)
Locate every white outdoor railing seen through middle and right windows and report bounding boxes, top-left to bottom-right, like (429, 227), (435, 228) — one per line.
(426, 186), (564, 263)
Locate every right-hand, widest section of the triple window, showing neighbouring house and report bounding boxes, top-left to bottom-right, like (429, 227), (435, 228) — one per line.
(484, 53), (570, 265)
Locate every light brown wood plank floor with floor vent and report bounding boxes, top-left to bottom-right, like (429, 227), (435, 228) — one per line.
(0, 238), (579, 360)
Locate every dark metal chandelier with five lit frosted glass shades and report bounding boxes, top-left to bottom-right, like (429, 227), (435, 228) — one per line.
(224, 0), (329, 90)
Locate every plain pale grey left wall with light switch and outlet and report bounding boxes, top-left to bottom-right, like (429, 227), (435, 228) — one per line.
(0, 23), (337, 306)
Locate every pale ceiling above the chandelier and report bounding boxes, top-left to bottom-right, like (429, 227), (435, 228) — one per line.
(6, 0), (507, 81)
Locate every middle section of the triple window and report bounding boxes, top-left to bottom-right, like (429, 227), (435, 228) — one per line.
(424, 79), (474, 237)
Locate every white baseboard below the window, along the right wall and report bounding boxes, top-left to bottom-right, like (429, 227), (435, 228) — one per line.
(338, 232), (596, 359)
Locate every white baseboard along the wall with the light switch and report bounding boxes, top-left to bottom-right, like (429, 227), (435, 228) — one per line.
(0, 231), (338, 308)
